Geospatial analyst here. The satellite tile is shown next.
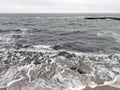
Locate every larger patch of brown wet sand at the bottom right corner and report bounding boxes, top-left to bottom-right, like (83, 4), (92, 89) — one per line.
(83, 86), (120, 90)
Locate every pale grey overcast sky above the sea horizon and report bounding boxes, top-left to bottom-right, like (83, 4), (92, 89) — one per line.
(0, 0), (120, 13)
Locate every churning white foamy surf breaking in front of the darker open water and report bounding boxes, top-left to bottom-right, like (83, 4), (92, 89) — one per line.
(0, 45), (120, 90)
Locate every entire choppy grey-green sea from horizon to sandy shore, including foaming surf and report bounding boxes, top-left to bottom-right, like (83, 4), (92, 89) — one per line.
(0, 14), (120, 90)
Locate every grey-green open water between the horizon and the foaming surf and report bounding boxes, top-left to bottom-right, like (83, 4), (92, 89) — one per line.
(0, 14), (120, 53)
